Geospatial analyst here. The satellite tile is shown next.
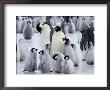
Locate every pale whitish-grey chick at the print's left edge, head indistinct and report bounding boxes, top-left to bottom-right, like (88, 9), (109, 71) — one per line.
(17, 39), (28, 61)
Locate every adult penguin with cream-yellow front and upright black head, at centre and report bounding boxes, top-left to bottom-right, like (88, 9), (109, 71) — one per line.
(51, 26), (65, 54)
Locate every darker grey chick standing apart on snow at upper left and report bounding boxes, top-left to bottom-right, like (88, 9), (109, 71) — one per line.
(23, 21), (33, 40)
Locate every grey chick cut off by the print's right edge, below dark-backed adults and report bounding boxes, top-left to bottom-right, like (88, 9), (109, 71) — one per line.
(86, 42), (94, 65)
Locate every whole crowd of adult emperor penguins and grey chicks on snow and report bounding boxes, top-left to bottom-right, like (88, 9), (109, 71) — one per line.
(16, 16), (94, 74)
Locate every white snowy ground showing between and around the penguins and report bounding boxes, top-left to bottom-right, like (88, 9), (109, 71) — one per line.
(16, 32), (94, 74)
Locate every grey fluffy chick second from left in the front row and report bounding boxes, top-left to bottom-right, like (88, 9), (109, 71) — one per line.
(38, 50), (53, 73)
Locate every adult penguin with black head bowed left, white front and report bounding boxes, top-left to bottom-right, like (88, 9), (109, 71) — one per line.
(36, 23), (51, 49)
